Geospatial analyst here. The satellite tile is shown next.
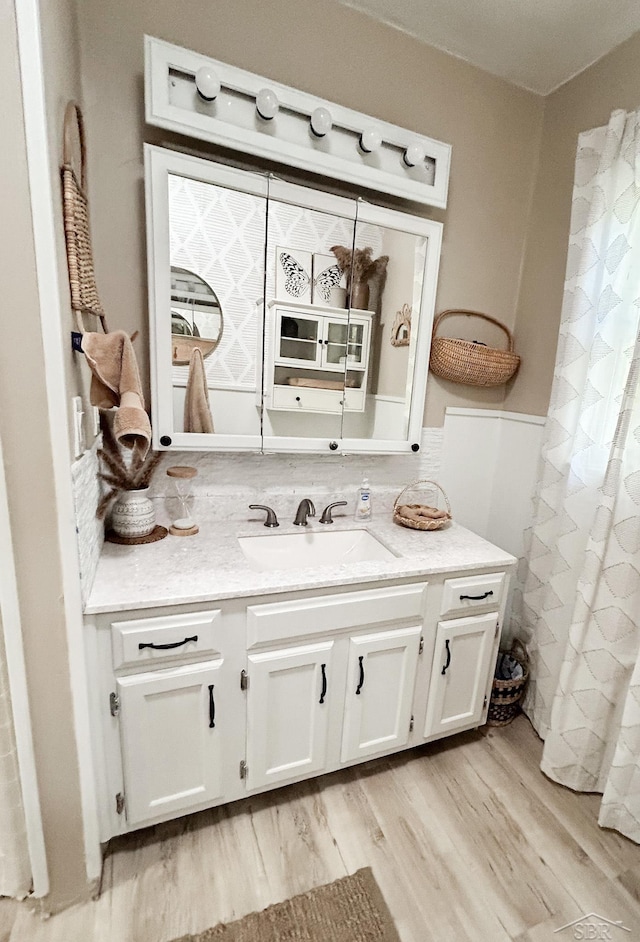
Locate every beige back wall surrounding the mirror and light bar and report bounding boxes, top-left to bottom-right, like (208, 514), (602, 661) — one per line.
(78, 0), (543, 425)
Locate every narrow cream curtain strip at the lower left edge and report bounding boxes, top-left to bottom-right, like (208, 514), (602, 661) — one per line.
(0, 610), (31, 899)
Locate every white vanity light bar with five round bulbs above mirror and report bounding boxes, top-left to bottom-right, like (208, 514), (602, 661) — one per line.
(145, 36), (451, 208)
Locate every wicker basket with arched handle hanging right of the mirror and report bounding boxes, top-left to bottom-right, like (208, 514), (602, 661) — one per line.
(429, 309), (520, 386)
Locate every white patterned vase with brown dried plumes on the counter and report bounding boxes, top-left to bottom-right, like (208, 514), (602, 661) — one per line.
(96, 412), (166, 542)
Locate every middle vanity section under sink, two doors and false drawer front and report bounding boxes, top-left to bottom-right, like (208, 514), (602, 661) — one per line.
(246, 583), (427, 790)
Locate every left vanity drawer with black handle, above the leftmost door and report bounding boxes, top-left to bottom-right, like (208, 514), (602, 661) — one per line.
(111, 609), (222, 670)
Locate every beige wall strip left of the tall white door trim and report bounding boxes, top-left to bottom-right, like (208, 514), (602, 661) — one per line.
(0, 0), (87, 909)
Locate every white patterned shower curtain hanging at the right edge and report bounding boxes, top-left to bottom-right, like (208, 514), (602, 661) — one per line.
(521, 111), (640, 842)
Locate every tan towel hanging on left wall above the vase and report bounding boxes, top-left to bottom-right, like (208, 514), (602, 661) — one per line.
(82, 330), (151, 457)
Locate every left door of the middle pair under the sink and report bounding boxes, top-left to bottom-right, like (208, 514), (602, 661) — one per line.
(247, 641), (335, 789)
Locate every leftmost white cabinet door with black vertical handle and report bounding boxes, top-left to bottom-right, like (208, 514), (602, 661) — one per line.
(118, 659), (224, 824)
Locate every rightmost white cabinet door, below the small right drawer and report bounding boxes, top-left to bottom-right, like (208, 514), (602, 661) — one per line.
(424, 612), (498, 737)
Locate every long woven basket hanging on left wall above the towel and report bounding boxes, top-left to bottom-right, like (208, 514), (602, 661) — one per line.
(61, 101), (107, 334)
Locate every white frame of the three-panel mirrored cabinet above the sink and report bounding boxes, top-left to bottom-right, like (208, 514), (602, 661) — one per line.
(144, 144), (442, 455)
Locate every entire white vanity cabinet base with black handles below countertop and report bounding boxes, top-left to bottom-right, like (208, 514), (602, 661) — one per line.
(87, 566), (508, 840)
